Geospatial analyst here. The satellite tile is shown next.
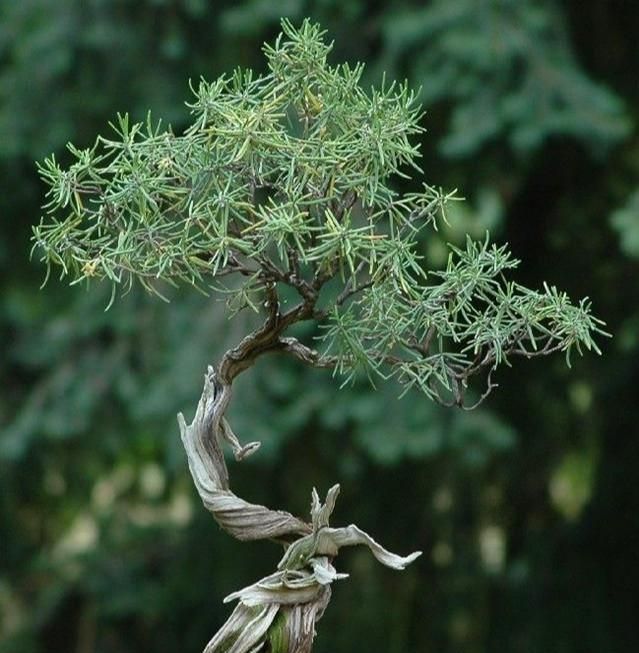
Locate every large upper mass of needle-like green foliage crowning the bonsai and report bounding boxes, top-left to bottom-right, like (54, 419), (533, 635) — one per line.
(31, 19), (430, 287)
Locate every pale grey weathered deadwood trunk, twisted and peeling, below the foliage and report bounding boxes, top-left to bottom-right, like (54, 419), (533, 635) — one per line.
(178, 366), (421, 653)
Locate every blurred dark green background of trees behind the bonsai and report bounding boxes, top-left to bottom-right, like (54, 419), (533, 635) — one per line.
(0, 0), (639, 653)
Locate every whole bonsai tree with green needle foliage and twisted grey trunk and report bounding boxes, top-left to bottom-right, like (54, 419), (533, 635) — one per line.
(34, 21), (603, 653)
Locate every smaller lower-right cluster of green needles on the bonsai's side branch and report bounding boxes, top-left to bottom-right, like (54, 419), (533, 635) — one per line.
(325, 237), (604, 405)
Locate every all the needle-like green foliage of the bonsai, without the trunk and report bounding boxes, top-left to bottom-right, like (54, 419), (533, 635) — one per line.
(34, 21), (603, 405)
